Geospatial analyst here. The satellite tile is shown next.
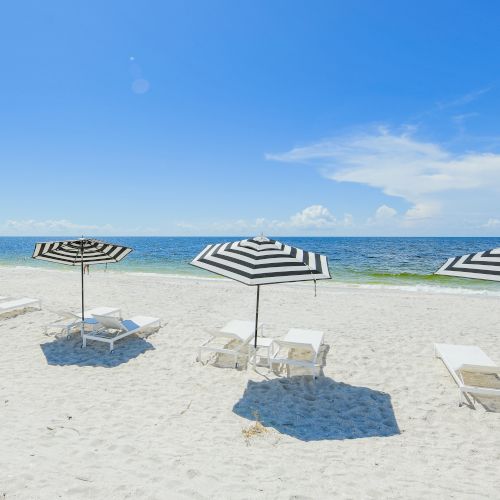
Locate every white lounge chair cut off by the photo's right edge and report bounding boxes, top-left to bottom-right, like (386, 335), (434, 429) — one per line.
(434, 344), (500, 406)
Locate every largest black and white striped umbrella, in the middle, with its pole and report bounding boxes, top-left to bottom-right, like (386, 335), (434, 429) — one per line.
(191, 236), (331, 346)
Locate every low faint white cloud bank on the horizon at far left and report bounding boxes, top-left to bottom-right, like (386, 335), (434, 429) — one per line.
(0, 219), (113, 236)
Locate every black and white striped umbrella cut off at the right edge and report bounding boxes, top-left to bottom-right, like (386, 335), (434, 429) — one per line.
(434, 248), (500, 281)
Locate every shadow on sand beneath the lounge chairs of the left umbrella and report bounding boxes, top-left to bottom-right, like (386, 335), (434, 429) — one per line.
(40, 335), (154, 368)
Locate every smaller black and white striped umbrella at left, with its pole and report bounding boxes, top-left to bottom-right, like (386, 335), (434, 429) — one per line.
(33, 238), (132, 330)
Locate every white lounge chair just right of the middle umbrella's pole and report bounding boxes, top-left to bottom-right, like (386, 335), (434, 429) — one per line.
(269, 328), (324, 378)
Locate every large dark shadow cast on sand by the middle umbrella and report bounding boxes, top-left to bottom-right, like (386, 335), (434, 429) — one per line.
(233, 377), (400, 441)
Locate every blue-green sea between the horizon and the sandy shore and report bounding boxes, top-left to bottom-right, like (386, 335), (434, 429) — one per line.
(0, 236), (500, 291)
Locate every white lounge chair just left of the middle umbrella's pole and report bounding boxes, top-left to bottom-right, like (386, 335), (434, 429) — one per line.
(196, 320), (264, 368)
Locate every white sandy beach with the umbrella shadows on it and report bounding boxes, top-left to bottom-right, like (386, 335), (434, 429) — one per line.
(0, 267), (500, 499)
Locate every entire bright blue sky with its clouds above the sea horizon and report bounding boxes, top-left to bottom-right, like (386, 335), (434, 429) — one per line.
(0, 0), (500, 236)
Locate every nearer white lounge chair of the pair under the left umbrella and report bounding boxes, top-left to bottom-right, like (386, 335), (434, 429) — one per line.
(82, 314), (161, 352)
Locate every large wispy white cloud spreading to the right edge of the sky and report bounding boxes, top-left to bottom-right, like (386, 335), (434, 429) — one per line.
(266, 127), (500, 220)
